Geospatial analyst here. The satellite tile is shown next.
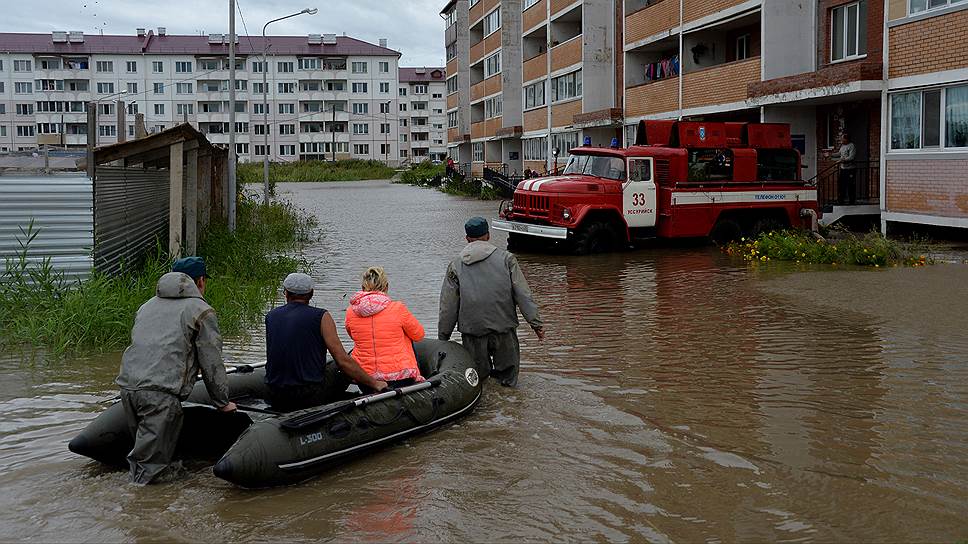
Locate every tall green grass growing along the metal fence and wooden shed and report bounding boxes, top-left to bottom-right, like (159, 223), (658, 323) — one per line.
(0, 199), (314, 354)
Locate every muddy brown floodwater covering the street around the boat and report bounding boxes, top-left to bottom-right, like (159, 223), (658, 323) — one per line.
(0, 182), (968, 542)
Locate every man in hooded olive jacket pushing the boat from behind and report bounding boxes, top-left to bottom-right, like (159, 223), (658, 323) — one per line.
(115, 257), (235, 484)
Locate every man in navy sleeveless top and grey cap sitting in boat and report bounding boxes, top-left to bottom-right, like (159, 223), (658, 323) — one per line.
(266, 273), (387, 411)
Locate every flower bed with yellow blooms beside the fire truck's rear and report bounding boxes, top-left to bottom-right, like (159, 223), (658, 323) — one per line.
(724, 230), (933, 268)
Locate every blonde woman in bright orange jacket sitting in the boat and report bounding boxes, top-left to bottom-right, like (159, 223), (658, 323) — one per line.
(346, 266), (424, 387)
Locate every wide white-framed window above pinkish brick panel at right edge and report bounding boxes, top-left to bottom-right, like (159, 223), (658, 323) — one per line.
(890, 85), (968, 150)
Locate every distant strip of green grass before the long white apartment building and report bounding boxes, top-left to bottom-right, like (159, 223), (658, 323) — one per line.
(236, 159), (395, 186)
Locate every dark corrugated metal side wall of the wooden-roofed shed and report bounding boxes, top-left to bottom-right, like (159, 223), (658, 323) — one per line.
(94, 166), (171, 274)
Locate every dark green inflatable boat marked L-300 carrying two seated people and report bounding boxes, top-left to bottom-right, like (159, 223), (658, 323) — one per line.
(68, 340), (483, 488)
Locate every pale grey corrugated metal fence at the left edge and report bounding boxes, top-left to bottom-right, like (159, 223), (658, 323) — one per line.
(0, 174), (94, 279)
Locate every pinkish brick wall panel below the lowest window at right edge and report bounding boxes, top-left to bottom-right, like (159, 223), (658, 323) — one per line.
(886, 160), (968, 218)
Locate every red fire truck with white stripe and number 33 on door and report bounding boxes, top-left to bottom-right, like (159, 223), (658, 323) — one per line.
(492, 121), (818, 254)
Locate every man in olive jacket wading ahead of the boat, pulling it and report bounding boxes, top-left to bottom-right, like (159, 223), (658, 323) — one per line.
(437, 217), (544, 387)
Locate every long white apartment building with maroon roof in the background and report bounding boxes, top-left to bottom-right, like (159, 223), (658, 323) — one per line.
(0, 28), (400, 164)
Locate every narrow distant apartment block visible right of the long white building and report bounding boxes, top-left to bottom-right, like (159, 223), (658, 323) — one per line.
(398, 67), (447, 164)
